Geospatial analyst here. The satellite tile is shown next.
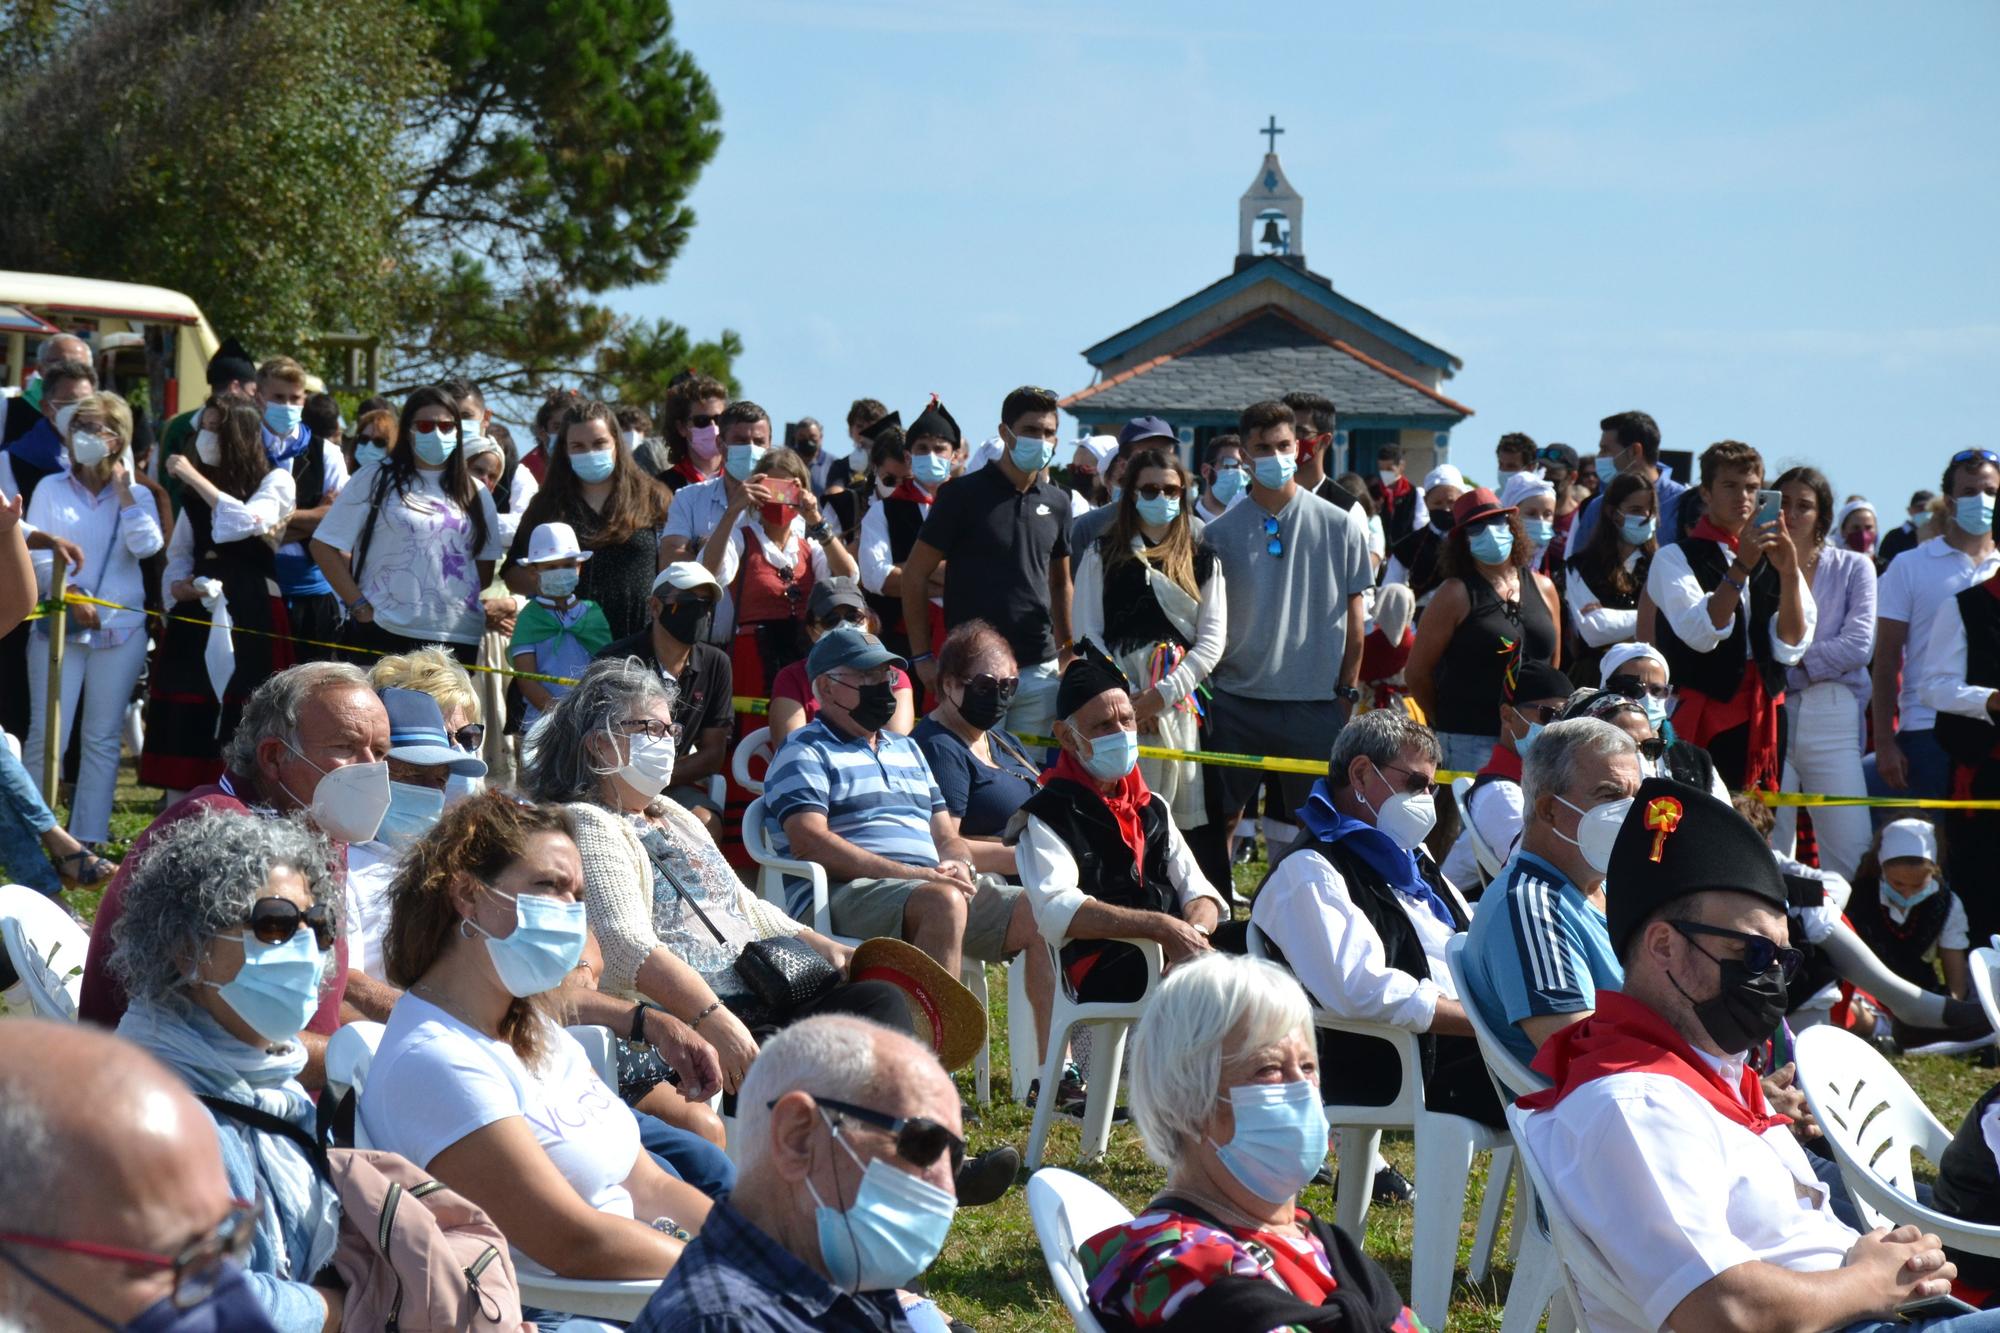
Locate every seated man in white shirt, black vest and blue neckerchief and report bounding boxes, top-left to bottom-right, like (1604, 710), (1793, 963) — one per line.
(1250, 709), (1506, 1125)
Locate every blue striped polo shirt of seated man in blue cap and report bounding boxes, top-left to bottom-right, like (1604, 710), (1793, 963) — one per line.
(764, 717), (946, 915)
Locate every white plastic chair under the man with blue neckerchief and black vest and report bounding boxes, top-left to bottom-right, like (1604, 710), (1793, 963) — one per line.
(1240, 925), (1514, 1329)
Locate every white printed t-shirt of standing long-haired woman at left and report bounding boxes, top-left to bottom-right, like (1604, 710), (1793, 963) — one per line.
(316, 462), (506, 642)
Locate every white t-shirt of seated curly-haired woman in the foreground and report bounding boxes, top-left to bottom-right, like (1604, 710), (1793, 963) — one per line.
(360, 993), (640, 1240)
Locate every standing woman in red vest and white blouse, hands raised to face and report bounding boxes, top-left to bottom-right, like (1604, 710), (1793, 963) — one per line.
(702, 448), (858, 697)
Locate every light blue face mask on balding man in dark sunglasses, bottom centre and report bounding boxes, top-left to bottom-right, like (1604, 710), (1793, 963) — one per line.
(806, 1111), (958, 1291)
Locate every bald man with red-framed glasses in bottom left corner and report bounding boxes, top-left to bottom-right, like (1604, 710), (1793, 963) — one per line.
(0, 1019), (276, 1333)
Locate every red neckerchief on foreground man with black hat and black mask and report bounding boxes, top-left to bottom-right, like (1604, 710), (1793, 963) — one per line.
(1520, 991), (1792, 1135)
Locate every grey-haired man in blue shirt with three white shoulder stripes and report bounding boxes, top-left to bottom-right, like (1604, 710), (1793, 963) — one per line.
(1464, 717), (1640, 1063)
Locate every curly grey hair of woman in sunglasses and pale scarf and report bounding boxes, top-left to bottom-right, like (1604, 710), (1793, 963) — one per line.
(110, 811), (340, 1005)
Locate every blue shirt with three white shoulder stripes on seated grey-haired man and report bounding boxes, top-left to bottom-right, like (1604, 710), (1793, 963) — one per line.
(1460, 851), (1624, 1065)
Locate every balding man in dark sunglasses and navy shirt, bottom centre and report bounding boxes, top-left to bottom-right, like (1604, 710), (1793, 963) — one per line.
(632, 1015), (966, 1333)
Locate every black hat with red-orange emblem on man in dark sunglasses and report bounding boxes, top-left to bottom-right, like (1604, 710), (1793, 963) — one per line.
(1604, 779), (1790, 955)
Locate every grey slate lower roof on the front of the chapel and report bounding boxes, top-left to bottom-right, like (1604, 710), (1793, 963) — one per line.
(1062, 306), (1472, 420)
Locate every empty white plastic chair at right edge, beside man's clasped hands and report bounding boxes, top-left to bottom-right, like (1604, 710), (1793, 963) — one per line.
(1796, 1020), (2000, 1257)
